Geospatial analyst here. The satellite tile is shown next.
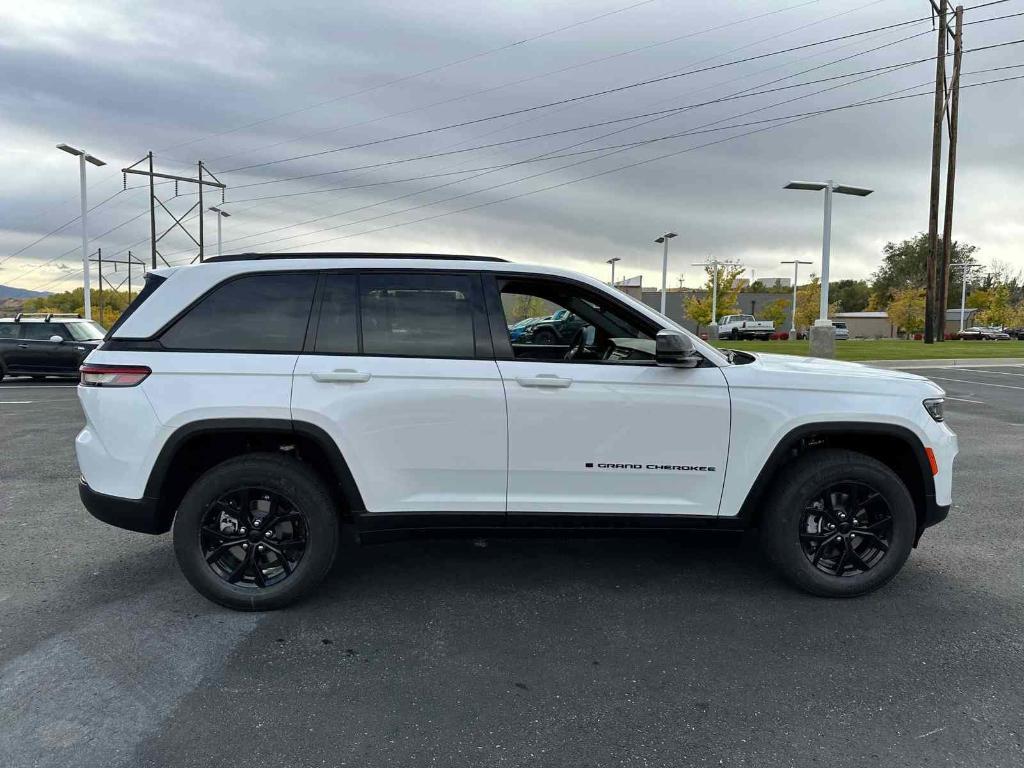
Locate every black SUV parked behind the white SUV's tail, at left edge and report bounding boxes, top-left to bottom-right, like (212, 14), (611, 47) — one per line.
(0, 313), (106, 380)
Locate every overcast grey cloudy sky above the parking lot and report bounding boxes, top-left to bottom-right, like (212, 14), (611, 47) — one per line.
(0, 0), (1024, 290)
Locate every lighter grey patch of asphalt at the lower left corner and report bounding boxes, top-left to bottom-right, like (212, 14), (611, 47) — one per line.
(0, 595), (261, 768)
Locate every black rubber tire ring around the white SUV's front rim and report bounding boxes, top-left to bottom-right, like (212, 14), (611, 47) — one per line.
(761, 450), (916, 597)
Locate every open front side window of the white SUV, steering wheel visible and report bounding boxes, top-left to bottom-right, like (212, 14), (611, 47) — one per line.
(499, 279), (654, 362)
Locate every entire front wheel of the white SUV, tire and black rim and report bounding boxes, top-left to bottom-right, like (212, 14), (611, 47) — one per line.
(761, 449), (916, 597)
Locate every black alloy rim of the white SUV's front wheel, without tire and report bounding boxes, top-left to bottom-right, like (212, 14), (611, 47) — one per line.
(799, 481), (893, 578)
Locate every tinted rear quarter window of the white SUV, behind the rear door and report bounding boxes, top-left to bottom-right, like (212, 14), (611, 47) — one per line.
(161, 272), (316, 352)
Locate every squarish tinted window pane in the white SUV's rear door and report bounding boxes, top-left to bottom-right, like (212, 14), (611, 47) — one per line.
(359, 273), (475, 357)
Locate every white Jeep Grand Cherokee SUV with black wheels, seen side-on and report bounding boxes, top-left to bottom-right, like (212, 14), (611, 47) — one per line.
(77, 254), (956, 609)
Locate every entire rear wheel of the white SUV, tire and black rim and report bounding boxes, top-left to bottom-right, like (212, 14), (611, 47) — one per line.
(173, 454), (339, 610)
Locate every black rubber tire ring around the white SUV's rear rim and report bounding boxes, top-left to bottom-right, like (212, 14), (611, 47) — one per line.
(173, 455), (338, 610)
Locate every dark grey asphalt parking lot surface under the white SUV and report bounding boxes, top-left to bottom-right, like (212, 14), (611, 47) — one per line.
(0, 366), (1024, 768)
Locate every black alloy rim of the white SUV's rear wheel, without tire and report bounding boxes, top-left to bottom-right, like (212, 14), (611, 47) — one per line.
(199, 487), (308, 589)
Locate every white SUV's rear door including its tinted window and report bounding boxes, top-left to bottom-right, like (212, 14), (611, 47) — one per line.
(292, 270), (508, 522)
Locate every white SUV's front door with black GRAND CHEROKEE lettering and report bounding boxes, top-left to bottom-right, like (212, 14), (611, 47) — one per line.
(492, 276), (729, 524)
